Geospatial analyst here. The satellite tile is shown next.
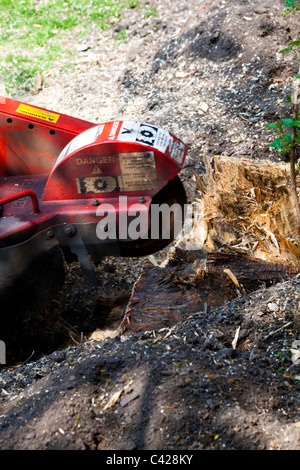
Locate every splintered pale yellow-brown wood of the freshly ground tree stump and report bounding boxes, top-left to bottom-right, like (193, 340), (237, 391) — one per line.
(195, 156), (300, 266)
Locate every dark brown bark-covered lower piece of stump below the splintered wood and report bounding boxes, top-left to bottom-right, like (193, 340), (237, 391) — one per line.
(121, 253), (300, 334)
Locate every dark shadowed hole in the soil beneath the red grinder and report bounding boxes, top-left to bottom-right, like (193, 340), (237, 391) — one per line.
(0, 263), (131, 366)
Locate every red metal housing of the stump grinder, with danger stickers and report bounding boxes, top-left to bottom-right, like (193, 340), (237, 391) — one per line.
(0, 98), (186, 246)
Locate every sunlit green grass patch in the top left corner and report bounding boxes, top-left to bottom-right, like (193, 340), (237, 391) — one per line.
(0, 0), (139, 96)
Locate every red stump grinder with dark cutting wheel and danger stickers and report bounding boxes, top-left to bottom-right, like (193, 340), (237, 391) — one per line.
(0, 97), (187, 320)
